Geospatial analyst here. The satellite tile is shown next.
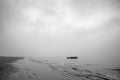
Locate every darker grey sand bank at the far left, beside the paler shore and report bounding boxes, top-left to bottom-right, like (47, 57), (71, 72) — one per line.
(0, 56), (24, 80)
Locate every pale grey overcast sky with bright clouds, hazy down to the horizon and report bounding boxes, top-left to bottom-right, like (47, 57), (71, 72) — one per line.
(0, 0), (120, 63)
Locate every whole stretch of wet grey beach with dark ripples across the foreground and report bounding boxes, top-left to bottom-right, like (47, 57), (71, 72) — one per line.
(0, 57), (120, 80)
